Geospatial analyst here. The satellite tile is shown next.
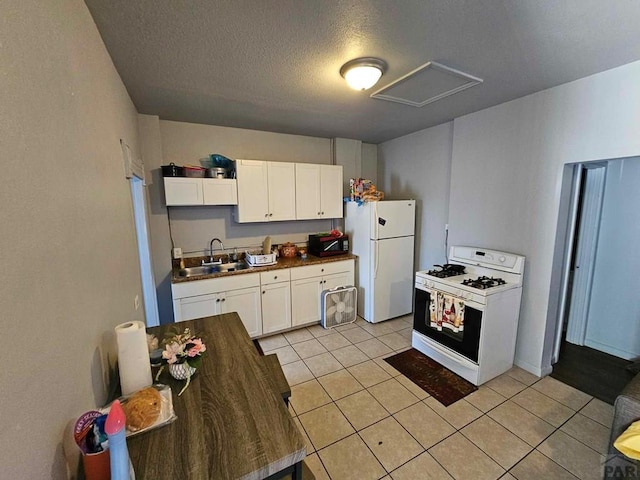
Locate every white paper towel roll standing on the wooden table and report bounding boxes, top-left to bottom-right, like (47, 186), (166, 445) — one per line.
(115, 321), (152, 395)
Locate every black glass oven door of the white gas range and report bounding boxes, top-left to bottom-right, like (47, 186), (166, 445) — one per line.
(413, 288), (483, 363)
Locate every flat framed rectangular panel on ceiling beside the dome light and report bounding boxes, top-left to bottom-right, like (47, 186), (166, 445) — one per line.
(371, 62), (482, 107)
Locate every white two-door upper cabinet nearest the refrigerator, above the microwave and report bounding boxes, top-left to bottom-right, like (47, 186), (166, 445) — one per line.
(296, 163), (342, 220)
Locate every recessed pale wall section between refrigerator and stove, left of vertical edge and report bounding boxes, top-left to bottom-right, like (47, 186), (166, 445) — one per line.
(378, 123), (453, 270)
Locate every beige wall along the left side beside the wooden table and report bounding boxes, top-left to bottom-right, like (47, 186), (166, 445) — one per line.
(0, 0), (143, 479)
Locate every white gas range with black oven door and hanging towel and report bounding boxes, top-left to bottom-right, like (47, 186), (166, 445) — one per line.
(412, 246), (525, 385)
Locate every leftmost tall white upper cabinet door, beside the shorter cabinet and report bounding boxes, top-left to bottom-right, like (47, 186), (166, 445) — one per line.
(235, 160), (269, 223)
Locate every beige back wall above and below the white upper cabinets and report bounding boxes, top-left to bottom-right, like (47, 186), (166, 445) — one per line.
(139, 119), (360, 323)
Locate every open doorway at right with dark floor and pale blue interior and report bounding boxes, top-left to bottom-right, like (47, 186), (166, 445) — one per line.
(552, 157), (640, 402)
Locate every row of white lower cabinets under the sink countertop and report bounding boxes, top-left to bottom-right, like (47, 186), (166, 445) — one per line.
(171, 260), (354, 337)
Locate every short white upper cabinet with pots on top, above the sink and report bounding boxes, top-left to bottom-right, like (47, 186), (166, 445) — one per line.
(164, 177), (238, 206)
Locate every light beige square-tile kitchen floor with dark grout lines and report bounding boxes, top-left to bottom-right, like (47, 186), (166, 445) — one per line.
(260, 316), (613, 480)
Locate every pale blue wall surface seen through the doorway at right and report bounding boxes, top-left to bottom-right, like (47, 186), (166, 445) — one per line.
(585, 157), (640, 360)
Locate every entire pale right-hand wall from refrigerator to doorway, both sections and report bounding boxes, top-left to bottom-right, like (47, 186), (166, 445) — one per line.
(378, 62), (640, 375)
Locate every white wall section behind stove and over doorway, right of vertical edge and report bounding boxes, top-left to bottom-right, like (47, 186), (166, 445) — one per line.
(449, 62), (640, 374)
